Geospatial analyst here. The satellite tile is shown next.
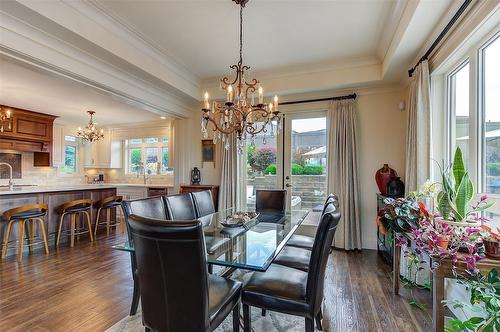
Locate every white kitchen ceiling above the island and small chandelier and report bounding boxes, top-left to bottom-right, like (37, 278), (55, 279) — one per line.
(0, 56), (165, 125)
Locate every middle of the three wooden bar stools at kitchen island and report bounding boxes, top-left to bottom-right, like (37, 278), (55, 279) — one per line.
(56, 199), (94, 247)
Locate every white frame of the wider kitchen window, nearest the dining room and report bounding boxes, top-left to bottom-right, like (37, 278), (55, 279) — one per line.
(123, 135), (173, 176)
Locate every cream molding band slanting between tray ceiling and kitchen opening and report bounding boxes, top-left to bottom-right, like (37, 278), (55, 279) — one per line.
(14, 0), (200, 98)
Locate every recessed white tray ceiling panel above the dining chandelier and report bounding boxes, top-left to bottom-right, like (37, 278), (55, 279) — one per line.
(93, 0), (396, 78)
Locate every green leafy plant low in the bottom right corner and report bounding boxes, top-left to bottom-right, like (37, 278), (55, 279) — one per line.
(444, 269), (500, 332)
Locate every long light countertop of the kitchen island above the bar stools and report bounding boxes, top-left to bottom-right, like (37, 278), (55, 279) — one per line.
(0, 183), (173, 196)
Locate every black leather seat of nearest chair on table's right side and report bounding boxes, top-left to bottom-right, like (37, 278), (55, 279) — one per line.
(241, 264), (309, 316)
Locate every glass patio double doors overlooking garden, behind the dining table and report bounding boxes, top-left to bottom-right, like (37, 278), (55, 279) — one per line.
(239, 111), (327, 210)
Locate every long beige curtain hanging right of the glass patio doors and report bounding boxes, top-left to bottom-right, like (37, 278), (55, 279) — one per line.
(328, 99), (361, 250)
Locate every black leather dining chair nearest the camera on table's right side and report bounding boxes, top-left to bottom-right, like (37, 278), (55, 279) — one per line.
(241, 203), (340, 332)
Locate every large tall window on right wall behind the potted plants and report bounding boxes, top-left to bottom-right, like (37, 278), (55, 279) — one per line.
(447, 28), (500, 228)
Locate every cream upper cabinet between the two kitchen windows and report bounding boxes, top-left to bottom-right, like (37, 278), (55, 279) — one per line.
(83, 129), (122, 168)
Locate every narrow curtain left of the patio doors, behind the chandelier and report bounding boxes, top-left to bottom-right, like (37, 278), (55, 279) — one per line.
(218, 133), (238, 211)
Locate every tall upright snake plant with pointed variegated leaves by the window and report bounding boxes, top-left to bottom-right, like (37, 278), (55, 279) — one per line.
(436, 147), (493, 222)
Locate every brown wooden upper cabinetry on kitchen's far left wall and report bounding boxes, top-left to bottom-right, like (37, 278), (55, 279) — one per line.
(0, 105), (57, 166)
